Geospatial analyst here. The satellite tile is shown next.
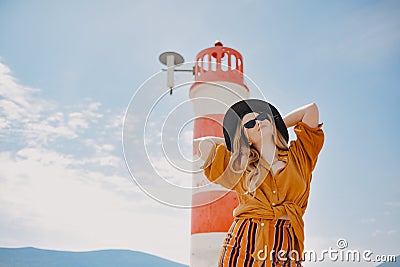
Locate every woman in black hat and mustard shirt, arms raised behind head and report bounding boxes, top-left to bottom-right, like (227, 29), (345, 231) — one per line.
(197, 99), (324, 267)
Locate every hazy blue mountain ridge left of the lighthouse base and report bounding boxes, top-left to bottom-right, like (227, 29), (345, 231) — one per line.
(0, 247), (188, 267)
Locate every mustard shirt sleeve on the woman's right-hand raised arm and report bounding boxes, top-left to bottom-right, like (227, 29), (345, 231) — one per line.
(291, 122), (324, 177)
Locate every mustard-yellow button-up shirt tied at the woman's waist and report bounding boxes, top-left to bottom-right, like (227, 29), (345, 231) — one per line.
(203, 122), (324, 260)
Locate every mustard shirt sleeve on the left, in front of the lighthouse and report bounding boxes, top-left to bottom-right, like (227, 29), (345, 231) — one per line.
(202, 144), (243, 190)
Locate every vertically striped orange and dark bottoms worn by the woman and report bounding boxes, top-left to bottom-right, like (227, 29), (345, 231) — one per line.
(218, 218), (301, 267)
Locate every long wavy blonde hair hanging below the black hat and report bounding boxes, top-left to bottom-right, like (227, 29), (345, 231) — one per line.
(229, 114), (289, 196)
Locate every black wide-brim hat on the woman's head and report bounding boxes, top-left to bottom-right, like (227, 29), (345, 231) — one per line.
(223, 99), (289, 151)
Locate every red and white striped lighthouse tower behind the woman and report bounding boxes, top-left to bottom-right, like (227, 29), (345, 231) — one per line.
(189, 41), (249, 267)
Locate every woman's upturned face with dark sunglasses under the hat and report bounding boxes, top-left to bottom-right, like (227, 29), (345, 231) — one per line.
(242, 112), (272, 145)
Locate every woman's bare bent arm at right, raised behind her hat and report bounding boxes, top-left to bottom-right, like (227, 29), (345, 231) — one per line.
(283, 103), (319, 128)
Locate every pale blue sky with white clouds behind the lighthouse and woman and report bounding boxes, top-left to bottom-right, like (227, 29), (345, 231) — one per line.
(0, 0), (400, 266)
